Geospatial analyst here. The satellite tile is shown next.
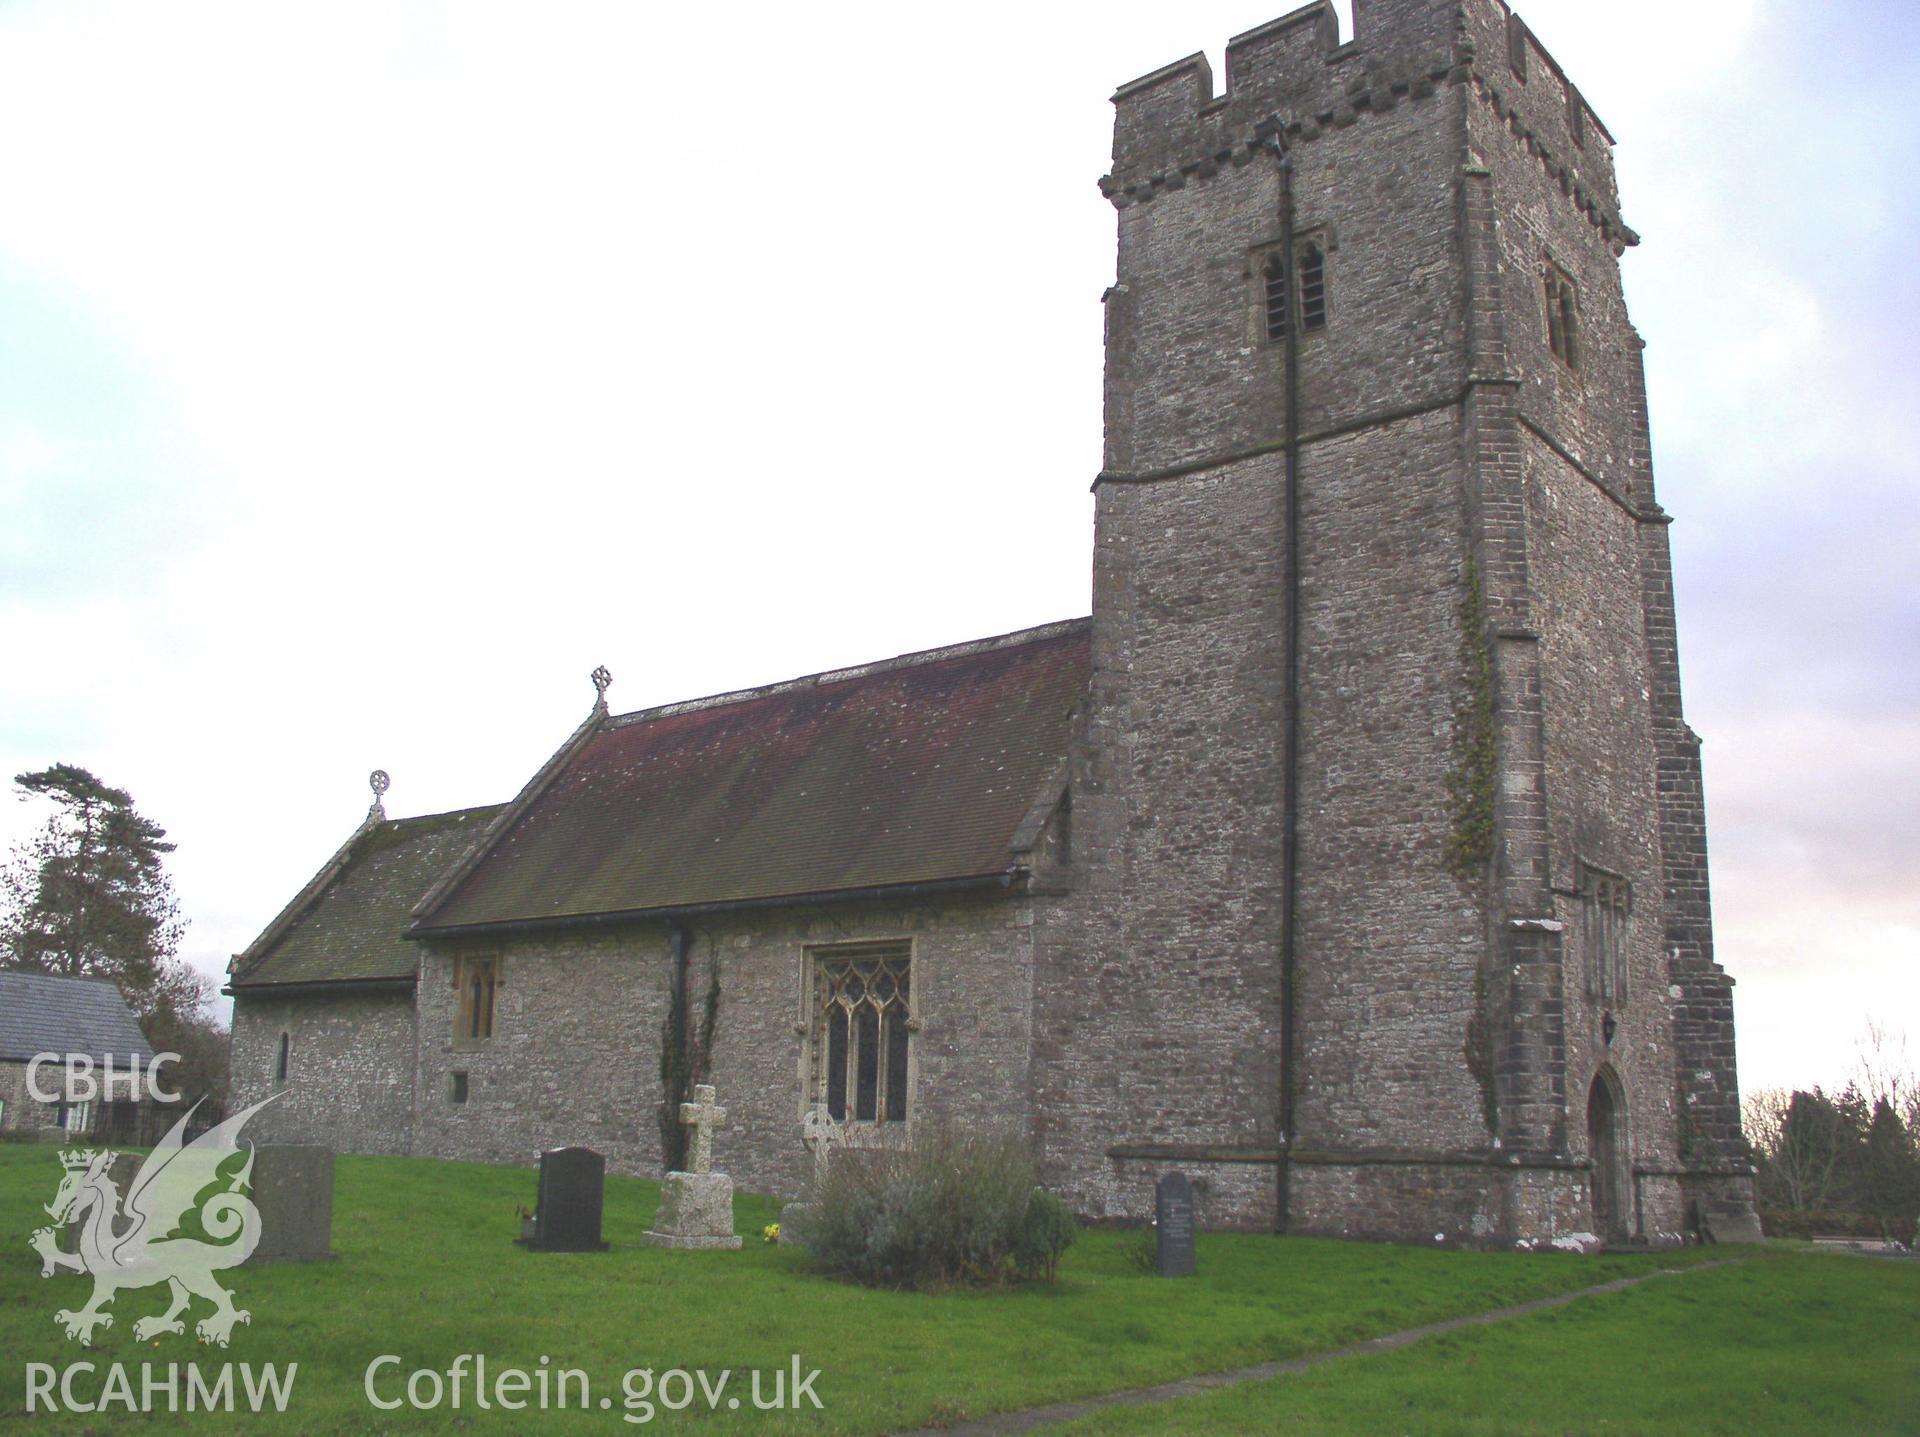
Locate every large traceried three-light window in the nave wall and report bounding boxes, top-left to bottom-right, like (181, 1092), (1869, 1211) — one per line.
(810, 943), (914, 1124)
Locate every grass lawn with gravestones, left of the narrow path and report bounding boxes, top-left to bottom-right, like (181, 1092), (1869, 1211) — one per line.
(0, 1143), (1758, 1433)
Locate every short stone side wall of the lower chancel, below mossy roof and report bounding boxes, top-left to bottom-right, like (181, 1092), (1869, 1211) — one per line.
(227, 989), (413, 1153)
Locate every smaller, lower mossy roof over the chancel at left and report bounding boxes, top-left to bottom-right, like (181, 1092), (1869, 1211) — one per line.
(230, 803), (505, 989)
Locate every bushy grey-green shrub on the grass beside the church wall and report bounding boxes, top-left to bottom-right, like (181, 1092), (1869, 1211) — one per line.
(795, 1128), (1073, 1289)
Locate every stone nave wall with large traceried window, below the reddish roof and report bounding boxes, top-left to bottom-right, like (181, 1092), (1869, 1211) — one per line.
(417, 893), (1033, 1195)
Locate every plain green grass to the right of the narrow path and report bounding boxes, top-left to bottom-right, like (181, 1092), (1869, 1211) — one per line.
(1046, 1254), (1920, 1437)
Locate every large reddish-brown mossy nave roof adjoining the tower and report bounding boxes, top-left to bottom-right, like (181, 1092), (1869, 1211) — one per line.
(415, 619), (1091, 934)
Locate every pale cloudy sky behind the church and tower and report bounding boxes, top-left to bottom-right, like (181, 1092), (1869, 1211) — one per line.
(0, 0), (1920, 1087)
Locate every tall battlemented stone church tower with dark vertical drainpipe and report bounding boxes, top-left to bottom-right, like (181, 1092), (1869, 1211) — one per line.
(1031, 0), (1753, 1241)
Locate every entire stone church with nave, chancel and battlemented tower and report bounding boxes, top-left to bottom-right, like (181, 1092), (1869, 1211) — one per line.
(228, 0), (1753, 1245)
